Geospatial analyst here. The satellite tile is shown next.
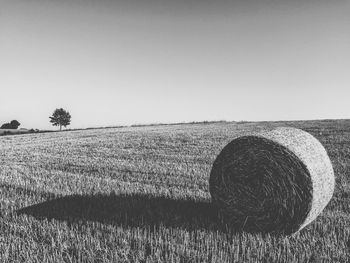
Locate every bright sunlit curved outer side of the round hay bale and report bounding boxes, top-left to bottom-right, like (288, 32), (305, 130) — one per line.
(254, 127), (335, 231)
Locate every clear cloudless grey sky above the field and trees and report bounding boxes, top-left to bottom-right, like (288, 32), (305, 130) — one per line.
(0, 0), (350, 129)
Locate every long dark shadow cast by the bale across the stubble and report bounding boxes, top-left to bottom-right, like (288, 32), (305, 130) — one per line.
(16, 194), (246, 233)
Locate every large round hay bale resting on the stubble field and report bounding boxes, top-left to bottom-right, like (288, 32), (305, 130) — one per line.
(209, 127), (335, 234)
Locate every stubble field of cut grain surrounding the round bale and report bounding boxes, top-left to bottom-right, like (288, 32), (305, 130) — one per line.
(0, 120), (350, 262)
